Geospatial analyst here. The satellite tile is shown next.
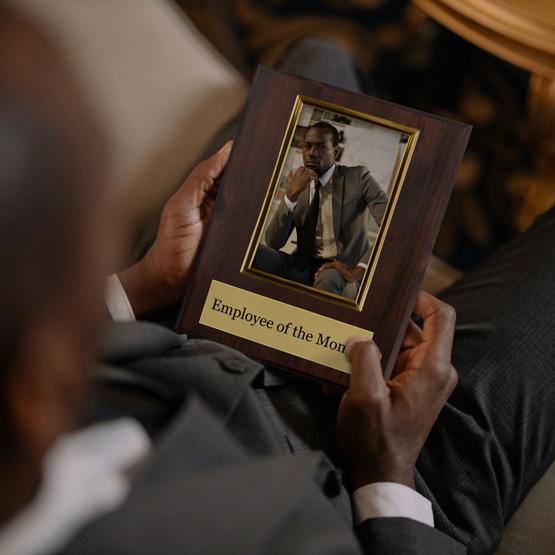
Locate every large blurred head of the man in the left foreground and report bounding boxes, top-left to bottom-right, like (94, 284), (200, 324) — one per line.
(0, 3), (112, 523)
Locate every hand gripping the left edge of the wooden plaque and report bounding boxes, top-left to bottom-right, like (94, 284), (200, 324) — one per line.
(119, 141), (232, 315)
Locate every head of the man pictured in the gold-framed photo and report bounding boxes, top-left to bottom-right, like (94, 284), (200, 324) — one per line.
(302, 121), (339, 176)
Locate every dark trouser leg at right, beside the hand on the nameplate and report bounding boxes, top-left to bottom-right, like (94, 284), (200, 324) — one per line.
(417, 208), (555, 553)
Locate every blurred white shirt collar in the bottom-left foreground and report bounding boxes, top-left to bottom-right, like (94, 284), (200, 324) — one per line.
(0, 419), (150, 555)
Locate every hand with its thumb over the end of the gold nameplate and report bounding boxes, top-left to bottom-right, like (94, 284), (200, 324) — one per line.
(337, 292), (457, 490)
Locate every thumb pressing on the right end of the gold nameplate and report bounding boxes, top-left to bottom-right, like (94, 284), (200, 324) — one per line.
(345, 336), (387, 397)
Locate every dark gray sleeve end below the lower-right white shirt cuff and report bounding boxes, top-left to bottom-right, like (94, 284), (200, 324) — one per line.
(357, 518), (467, 555)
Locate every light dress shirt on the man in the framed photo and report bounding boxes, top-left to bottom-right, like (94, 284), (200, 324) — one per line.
(284, 164), (367, 269)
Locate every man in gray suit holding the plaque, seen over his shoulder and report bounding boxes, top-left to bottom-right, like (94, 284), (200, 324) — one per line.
(0, 8), (555, 555)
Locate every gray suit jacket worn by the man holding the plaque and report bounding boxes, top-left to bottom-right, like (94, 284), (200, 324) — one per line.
(55, 323), (466, 555)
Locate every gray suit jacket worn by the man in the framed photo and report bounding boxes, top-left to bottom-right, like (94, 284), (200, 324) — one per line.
(265, 164), (388, 266)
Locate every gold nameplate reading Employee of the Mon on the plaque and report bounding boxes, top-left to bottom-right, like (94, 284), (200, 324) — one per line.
(200, 279), (374, 374)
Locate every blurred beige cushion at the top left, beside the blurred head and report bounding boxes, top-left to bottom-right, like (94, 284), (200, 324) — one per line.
(17, 0), (247, 227)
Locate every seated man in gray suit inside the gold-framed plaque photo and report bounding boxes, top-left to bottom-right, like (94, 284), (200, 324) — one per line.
(253, 121), (388, 298)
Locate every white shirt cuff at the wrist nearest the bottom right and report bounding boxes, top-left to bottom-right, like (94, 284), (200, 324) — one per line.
(352, 482), (434, 526)
